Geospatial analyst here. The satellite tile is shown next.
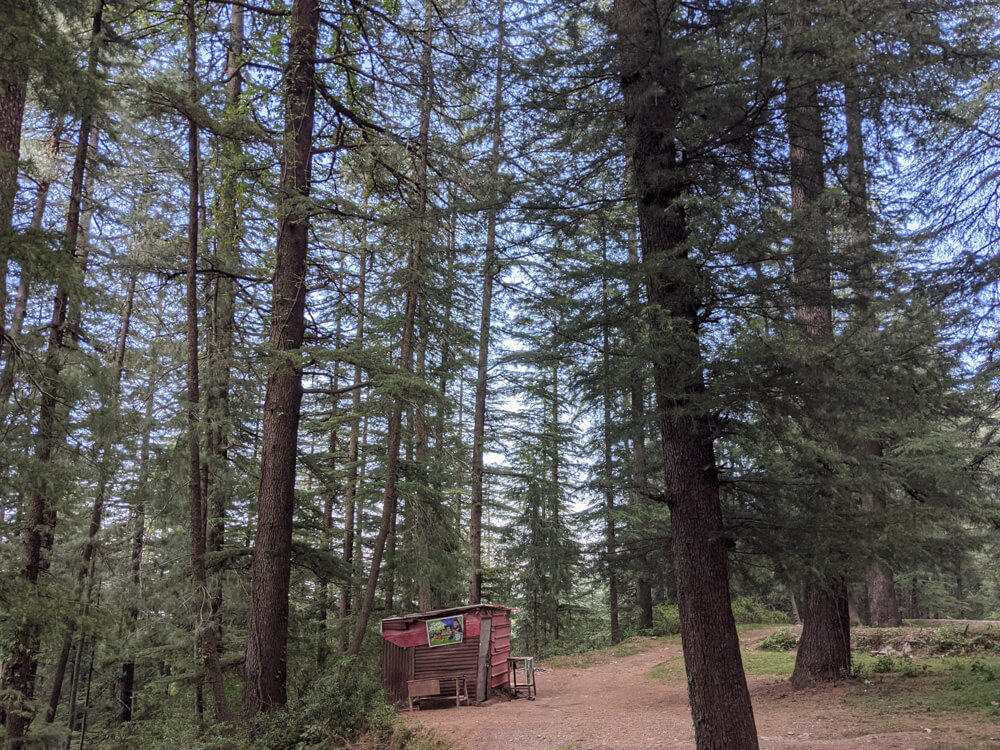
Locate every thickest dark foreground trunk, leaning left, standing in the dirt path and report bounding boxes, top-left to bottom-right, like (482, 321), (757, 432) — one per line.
(614, 0), (757, 750)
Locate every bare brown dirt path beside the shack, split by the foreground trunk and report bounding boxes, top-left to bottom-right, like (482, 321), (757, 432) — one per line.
(404, 631), (1000, 750)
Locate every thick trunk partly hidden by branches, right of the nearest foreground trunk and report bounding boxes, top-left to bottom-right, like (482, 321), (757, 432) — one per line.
(785, 15), (851, 687)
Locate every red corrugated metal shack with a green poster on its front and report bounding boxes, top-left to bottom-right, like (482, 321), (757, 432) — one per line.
(382, 604), (510, 703)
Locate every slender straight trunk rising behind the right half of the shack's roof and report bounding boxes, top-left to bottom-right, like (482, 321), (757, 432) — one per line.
(469, 0), (507, 604)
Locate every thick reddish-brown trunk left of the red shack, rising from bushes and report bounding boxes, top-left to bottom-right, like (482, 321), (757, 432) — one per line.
(243, 0), (320, 718)
